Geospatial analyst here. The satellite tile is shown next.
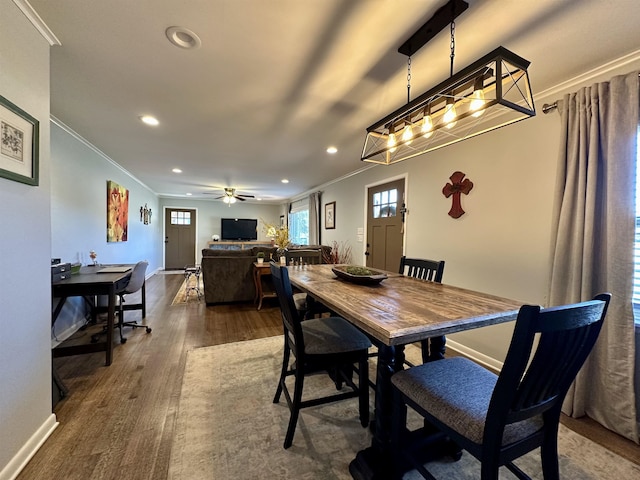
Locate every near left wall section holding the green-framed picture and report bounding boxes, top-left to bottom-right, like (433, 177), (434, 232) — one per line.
(0, 0), (56, 479)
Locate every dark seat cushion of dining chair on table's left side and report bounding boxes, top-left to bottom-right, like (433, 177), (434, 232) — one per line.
(301, 317), (371, 355)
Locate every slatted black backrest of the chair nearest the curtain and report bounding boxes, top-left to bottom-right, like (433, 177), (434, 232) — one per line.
(485, 294), (611, 430)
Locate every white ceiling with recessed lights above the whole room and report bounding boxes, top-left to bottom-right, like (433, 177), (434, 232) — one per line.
(29, 0), (640, 203)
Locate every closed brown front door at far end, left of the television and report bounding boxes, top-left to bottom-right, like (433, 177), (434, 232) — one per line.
(164, 208), (196, 270)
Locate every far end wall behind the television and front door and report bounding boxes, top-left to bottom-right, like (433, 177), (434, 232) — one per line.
(159, 197), (282, 263)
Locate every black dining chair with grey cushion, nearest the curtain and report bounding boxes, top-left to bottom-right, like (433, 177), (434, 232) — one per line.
(391, 293), (611, 480)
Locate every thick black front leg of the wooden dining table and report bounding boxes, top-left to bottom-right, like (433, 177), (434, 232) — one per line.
(349, 345), (404, 480)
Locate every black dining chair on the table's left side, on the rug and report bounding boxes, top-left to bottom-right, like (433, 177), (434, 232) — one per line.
(271, 262), (371, 448)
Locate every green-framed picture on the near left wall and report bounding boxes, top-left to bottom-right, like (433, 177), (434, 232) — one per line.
(0, 95), (40, 186)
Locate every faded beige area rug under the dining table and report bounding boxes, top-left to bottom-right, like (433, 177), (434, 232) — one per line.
(169, 337), (640, 480)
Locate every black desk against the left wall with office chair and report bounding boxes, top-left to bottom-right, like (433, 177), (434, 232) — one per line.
(51, 266), (133, 366)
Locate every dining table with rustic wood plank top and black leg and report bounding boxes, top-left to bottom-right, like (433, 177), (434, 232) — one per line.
(288, 265), (522, 479)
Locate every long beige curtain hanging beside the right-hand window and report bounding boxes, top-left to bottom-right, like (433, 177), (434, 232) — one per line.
(549, 72), (639, 442)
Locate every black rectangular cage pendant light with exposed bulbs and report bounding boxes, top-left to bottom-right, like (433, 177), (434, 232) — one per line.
(361, 0), (536, 165)
